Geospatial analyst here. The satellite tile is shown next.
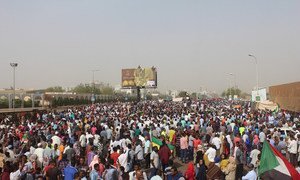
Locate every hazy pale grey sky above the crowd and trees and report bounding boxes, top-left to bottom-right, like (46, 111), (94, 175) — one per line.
(0, 0), (300, 92)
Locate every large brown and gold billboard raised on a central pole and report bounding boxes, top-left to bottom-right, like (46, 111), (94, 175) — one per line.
(122, 67), (157, 88)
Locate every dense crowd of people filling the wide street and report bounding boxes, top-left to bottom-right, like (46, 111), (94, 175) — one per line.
(0, 99), (300, 180)
